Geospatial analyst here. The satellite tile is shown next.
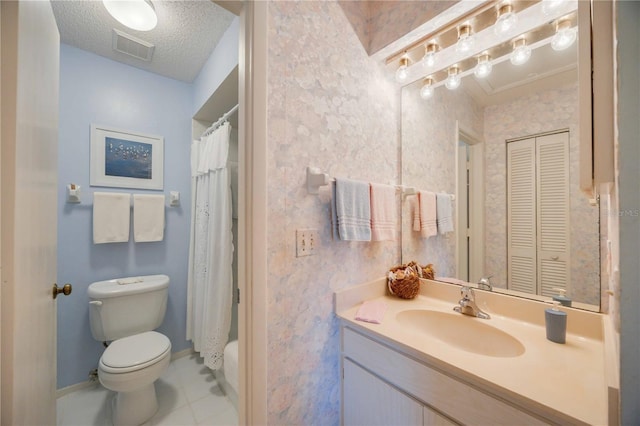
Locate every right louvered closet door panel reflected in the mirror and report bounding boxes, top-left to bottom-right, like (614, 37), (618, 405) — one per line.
(536, 132), (570, 296)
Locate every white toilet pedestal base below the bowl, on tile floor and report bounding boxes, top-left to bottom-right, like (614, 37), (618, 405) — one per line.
(112, 383), (158, 426)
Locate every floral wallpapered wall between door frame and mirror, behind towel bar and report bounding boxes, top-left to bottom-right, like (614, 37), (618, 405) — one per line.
(266, 1), (400, 425)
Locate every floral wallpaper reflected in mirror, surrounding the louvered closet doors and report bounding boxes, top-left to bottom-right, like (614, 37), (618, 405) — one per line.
(484, 84), (600, 305)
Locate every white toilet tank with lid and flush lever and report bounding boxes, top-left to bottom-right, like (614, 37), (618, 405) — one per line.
(88, 275), (169, 342)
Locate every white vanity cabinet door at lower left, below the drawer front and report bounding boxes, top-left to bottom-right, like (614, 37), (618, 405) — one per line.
(342, 358), (422, 426)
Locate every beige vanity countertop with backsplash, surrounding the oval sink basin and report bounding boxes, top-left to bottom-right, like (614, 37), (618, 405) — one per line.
(336, 279), (608, 425)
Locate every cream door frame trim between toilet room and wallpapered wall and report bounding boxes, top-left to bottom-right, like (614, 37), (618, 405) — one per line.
(238, 2), (268, 425)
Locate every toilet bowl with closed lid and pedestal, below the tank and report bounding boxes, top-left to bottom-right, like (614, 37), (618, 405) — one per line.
(98, 331), (171, 425)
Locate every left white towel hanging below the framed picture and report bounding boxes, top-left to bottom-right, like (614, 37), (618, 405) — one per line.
(93, 192), (131, 244)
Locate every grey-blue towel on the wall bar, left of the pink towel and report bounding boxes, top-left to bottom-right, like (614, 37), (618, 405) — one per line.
(335, 179), (371, 241)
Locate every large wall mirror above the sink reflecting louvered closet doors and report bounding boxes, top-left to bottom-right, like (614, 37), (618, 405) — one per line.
(401, 1), (601, 310)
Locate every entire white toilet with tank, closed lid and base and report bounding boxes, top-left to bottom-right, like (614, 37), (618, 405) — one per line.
(88, 275), (171, 426)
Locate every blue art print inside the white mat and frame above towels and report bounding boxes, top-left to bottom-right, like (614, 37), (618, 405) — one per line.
(104, 137), (153, 179)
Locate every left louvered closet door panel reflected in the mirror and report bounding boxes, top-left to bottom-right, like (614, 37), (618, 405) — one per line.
(507, 138), (538, 294)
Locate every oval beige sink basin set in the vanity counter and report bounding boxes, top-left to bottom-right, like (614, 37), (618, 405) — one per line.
(396, 309), (525, 358)
